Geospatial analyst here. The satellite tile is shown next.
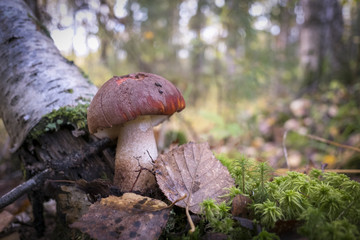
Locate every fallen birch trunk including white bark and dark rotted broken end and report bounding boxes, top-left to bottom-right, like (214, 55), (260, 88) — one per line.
(0, 0), (114, 235)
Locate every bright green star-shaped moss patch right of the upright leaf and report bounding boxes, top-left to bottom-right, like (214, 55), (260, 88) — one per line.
(211, 155), (360, 239)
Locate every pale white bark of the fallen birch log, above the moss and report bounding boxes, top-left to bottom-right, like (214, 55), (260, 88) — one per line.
(0, 0), (97, 152)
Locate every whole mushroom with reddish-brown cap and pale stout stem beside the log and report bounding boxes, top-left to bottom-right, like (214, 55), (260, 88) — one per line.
(87, 72), (185, 193)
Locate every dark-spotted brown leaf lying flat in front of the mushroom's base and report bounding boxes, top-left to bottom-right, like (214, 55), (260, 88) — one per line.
(71, 193), (170, 240)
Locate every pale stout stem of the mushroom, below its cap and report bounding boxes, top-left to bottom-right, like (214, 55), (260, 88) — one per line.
(114, 116), (158, 193)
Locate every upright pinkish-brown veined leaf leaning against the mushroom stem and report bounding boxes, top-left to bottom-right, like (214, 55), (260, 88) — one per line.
(155, 142), (234, 214)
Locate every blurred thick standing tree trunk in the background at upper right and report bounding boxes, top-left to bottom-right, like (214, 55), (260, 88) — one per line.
(300, 0), (352, 89)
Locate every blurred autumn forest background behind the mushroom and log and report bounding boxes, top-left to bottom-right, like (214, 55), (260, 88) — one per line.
(0, 0), (360, 168)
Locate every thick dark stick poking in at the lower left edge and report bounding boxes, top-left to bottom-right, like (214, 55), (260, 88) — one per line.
(0, 169), (51, 209)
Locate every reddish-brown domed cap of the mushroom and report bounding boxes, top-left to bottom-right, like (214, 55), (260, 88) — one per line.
(87, 72), (185, 133)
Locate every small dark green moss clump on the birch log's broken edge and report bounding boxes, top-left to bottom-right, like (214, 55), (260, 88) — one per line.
(27, 104), (89, 140)
